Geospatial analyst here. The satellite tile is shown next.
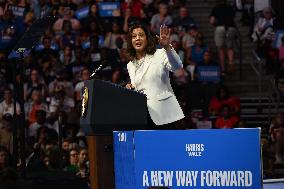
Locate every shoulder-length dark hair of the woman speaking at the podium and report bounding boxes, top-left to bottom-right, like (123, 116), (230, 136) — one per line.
(127, 24), (157, 60)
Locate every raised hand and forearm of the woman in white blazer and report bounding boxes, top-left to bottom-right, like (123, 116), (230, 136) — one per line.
(159, 25), (182, 72)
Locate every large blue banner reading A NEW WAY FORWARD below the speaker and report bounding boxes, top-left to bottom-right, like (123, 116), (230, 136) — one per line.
(114, 129), (262, 189)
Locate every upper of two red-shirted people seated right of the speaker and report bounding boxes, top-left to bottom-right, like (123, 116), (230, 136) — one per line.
(208, 85), (240, 116)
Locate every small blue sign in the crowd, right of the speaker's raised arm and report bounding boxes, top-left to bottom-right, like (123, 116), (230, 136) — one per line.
(197, 66), (220, 82)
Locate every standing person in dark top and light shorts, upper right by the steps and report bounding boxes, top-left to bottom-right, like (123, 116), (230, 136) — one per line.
(210, 0), (237, 75)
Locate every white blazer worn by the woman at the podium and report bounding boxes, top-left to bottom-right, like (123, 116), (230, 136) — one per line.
(127, 49), (184, 125)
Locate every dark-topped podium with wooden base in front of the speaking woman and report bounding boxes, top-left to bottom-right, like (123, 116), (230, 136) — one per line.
(80, 79), (148, 189)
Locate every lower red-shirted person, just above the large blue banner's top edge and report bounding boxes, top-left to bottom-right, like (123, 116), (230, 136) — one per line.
(215, 104), (239, 129)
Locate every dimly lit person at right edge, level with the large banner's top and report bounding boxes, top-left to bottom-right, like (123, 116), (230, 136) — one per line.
(269, 113), (284, 163)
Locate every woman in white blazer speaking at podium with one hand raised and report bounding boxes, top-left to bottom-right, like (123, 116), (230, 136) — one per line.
(126, 25), (184, 128)
